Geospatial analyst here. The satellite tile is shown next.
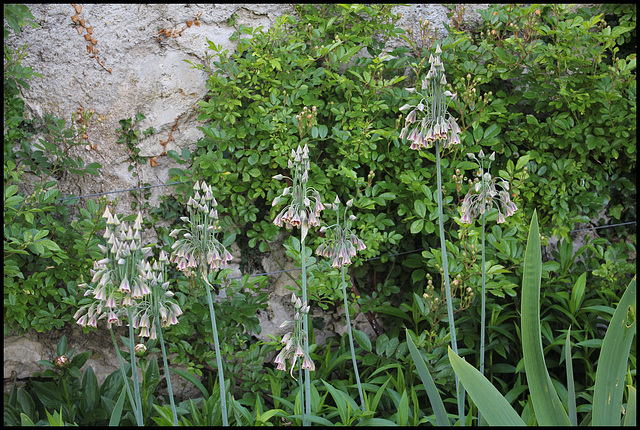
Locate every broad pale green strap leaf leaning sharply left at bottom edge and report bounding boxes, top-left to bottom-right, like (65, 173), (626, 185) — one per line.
(449, 347), (526, 426)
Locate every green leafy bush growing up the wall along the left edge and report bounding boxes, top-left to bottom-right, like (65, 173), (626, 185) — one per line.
(3, 5), (104, 333)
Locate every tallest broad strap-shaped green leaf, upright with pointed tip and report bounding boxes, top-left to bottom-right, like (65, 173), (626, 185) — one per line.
(521, 211), (571, 426)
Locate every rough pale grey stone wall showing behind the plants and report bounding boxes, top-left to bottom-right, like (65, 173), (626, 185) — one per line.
(4, 4), (481, 396)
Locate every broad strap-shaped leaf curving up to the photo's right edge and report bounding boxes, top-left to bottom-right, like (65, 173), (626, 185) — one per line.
(593, 276), (636, 426)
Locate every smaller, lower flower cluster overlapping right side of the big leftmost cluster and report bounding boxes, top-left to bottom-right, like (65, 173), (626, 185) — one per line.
(132, 251), (182, 339)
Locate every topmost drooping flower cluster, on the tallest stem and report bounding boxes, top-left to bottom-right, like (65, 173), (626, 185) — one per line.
(400, 45), (460, 150)
